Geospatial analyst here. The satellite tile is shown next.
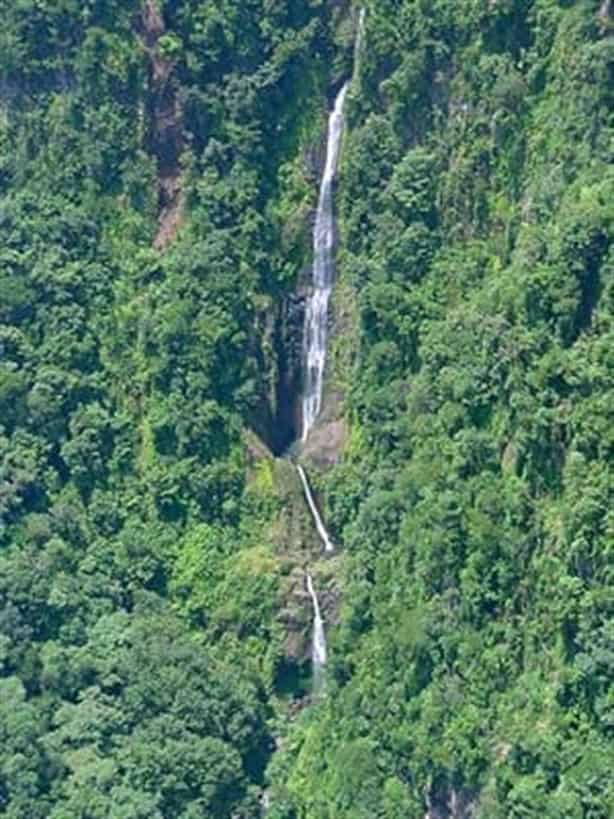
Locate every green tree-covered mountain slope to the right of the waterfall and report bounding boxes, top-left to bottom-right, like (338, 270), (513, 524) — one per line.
(272, 0), (614, 819)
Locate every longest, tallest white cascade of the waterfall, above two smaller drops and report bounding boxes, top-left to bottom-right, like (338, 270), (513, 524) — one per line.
(302, 82), (349, 441)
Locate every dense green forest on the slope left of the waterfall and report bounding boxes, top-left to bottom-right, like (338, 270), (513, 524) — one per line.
(0, 0), (330, 819)
